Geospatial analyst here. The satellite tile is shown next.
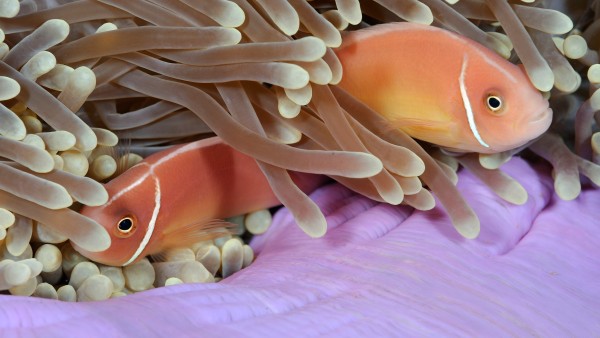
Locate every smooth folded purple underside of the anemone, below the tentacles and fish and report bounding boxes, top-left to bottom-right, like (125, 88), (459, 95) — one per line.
(0, 159), (600, 337)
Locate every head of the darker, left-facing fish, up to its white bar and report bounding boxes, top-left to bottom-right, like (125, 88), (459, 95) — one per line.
(74, 163), (158, 266)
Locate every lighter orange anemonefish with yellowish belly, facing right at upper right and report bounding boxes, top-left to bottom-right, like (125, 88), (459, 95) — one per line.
(336, 23), (552, 153)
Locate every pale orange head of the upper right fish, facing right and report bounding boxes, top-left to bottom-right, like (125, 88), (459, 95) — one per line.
(465, 54), (552, 153)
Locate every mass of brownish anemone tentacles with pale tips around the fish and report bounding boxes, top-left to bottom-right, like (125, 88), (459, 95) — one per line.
(0, 0), (600, 299)
